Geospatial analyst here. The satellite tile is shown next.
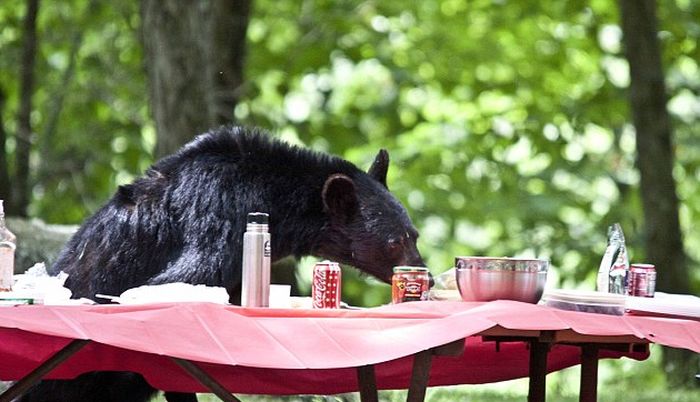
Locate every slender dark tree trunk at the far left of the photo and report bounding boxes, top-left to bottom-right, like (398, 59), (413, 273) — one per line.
(12, 0), (39, 216)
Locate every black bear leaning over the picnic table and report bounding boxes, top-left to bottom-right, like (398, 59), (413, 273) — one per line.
(24, 127), (423, 401)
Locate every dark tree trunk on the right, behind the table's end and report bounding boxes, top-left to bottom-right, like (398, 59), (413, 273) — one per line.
(620, 0), (697, 385)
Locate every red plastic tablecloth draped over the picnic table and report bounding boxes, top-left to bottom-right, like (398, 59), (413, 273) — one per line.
(0, 301), (700, 394)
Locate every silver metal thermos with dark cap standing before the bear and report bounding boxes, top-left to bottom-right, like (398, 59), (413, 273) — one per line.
(241, 212), (272, 307)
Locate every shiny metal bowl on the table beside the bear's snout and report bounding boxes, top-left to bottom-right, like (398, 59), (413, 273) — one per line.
(455, 257), (549, 303)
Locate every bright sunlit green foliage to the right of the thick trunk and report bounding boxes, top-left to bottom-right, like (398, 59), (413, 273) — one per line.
(236, 0), (700, 303)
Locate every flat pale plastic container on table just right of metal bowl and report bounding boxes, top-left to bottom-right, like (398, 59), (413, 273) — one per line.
(543, 289), (625, 315)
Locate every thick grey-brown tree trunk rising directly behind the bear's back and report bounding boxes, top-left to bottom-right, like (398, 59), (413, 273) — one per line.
(141, 0), (250, 157)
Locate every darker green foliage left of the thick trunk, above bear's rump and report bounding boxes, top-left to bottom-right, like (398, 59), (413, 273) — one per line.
(0, 0), (153, 223)
